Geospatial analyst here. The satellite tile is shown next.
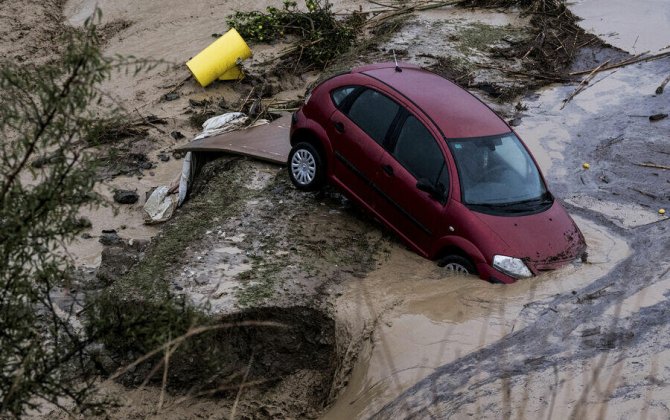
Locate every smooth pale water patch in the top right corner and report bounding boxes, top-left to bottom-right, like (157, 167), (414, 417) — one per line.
(568, 0), (670, 54)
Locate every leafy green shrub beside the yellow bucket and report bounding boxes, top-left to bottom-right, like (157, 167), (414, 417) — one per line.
(226, 0), (365, 68)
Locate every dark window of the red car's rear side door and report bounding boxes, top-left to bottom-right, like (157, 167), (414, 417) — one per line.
(347, 89), (400, 144)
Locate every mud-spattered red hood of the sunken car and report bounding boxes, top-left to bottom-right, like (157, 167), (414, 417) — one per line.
(477, 200), (586, 274)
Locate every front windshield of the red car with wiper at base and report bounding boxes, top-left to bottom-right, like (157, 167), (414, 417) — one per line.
(447, 132), (553, 211)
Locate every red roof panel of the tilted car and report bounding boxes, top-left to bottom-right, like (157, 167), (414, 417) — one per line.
(352, 63), (510, 138)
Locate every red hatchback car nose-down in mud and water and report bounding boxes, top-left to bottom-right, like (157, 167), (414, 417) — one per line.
(288, 63), (586, 283)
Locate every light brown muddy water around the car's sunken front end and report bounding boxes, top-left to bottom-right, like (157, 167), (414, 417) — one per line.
(325, 219), (629, 419)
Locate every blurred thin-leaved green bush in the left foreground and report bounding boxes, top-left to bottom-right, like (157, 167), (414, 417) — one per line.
(0, 13), (154, 416)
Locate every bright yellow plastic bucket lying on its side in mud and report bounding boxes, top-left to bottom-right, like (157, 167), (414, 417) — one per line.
(186, 28), (251, 87)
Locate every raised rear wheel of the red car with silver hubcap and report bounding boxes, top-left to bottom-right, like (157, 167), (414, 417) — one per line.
(287, 142), (326, 191)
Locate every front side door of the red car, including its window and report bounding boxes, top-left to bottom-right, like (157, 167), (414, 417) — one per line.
(376, 112), (450, 256)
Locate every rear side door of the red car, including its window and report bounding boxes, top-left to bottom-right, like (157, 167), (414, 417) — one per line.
(326, 86), (400, 208)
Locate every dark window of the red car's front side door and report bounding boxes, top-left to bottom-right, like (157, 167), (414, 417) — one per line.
(393, 115), (449, 193)
